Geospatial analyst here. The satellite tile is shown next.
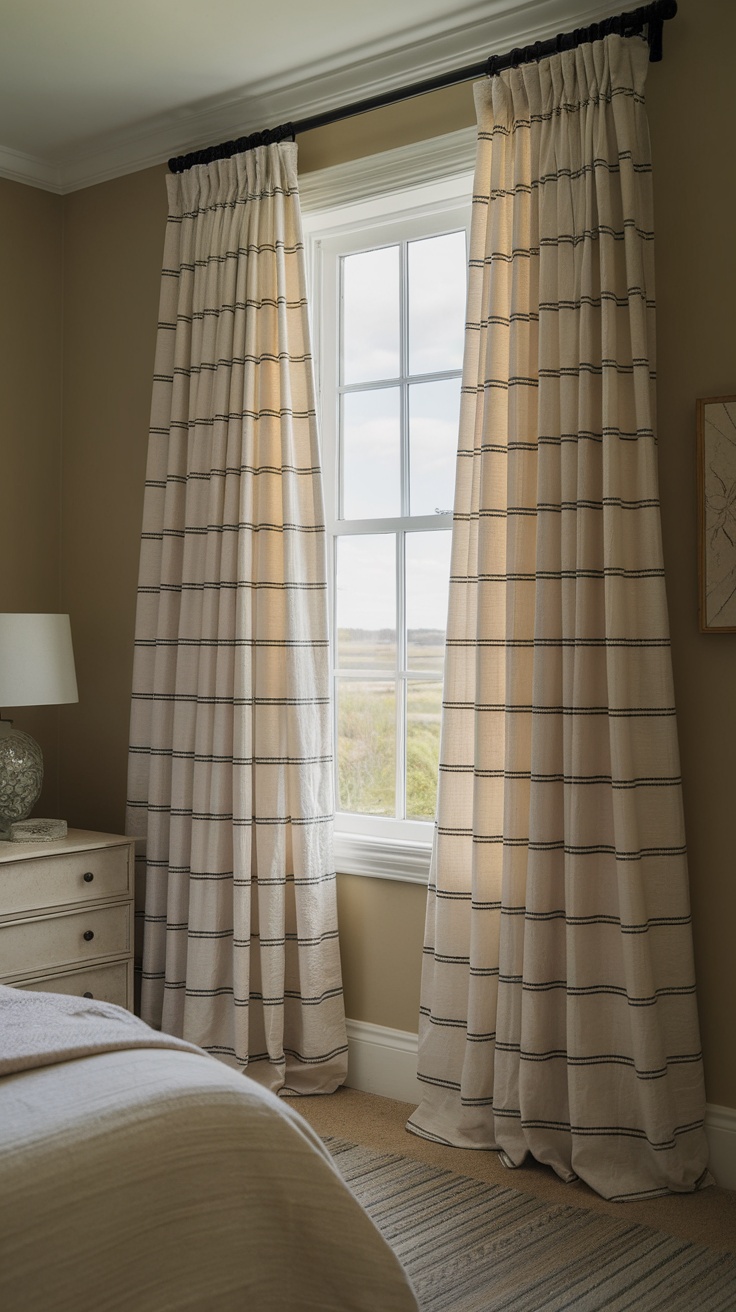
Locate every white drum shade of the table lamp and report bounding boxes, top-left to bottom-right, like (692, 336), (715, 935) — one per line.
(0, 614), (79, 707)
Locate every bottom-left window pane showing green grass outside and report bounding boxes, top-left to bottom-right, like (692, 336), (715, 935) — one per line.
(336, 678), (396, 816)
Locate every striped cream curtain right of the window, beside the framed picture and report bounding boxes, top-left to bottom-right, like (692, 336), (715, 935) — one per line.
(409, 37), (707, 1198)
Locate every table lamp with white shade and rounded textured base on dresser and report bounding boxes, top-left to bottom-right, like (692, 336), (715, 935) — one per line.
(0, 614), (79, 841)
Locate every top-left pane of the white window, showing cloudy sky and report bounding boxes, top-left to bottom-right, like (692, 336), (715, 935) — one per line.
(342, 245), (400, 383)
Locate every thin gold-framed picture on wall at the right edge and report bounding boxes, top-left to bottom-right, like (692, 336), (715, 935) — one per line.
(697, 396), (736, 634)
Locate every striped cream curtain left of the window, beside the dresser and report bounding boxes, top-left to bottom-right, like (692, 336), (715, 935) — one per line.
(127, 143), (346, 1093)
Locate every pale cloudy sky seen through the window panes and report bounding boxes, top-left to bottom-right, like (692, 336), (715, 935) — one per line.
(337, 231), (467, 640)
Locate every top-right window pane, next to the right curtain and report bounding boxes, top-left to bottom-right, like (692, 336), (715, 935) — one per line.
(408, 231), (467, 374)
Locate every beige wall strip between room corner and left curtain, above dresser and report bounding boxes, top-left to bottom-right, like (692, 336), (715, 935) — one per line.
(62, 168), (167, 833)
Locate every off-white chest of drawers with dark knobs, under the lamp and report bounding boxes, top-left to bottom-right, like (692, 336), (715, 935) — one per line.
(0, 829), (135, 1010)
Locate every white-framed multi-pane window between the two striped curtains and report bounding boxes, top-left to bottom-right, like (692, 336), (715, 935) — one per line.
(306, 143), (471, 879)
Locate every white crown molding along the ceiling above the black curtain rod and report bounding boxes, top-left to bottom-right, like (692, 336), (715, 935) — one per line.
(0, 0), (618, 193)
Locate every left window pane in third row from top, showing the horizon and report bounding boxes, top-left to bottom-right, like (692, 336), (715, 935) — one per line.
(336, 533), (396, 669)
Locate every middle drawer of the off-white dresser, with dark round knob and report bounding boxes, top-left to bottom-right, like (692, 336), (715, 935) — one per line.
(0, 903), (131, 979)
